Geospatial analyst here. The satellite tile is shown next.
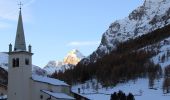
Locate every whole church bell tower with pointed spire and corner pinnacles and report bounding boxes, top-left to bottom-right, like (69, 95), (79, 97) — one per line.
(8, 8), (33, 100)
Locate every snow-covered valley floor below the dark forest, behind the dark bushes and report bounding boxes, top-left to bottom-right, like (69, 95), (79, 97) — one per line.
(72, 79), (170, 100)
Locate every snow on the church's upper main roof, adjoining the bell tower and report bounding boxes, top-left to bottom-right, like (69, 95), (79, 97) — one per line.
(32, 75), (69, 86)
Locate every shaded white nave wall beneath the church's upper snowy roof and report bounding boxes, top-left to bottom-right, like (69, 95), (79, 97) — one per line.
(31, 79), (73, 100)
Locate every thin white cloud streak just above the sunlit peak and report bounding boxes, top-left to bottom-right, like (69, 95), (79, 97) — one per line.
(67, 41), (100, 46)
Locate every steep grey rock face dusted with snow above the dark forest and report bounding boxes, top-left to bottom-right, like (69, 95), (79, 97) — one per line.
(81, 0), (170, 64)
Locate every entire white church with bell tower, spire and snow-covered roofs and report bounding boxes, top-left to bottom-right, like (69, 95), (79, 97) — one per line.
(7, 9), (75, 100)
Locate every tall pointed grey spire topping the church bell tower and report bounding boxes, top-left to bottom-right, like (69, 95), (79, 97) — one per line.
(14, 9), (26, 51)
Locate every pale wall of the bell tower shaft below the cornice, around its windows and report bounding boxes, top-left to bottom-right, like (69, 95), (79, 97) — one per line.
(8, 53), (31, 100)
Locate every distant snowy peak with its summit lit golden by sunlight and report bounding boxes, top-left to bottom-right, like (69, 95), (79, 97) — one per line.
(43, 49), (85, 74)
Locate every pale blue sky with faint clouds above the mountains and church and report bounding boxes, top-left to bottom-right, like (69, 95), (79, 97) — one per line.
(0, 0), (144, 67)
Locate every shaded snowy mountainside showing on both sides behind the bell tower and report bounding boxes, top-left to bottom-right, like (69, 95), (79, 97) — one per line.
(0, 52), (46, 75)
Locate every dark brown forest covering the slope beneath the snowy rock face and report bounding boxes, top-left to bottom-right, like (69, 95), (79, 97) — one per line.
(51, 25), (170, 87)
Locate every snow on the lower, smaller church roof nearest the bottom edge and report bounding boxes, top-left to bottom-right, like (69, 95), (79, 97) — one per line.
(41, 90), (75, 100)
